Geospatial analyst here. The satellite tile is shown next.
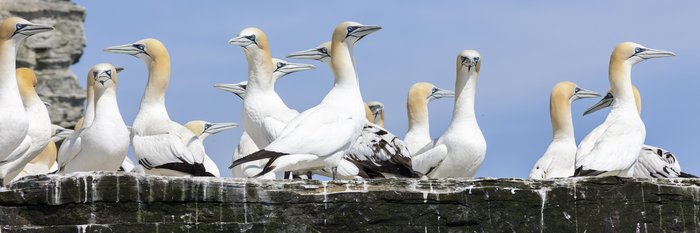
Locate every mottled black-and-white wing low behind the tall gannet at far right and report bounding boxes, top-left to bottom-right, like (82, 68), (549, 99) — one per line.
(634, 145), (681, 178)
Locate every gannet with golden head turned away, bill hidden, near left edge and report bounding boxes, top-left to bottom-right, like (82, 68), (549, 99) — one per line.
(0, 68), (51, 185)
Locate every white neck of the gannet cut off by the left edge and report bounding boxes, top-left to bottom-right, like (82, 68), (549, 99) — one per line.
(0, 39), (21, 99)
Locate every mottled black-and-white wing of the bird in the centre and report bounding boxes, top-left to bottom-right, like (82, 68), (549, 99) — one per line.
(344, 122), (421, 178)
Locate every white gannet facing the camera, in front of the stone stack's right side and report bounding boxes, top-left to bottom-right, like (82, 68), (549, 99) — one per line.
(58, 63), (129, 173)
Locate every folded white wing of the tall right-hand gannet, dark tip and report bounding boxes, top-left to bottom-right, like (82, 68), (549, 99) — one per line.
(575, 122), (645, 176)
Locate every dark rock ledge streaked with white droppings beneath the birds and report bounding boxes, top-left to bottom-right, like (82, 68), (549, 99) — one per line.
(0, 173), (700, 232)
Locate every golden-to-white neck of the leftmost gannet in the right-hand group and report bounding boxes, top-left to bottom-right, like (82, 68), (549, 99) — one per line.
(549, 96), (574, 141)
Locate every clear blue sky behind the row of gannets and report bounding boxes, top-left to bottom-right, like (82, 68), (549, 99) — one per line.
(72, 0), (700, 177)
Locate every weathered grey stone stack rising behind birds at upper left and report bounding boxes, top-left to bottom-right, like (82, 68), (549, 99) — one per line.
(0, 0), (85, 127)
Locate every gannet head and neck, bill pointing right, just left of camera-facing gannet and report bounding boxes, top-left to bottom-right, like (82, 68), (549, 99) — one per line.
(403, 82), (455, 155)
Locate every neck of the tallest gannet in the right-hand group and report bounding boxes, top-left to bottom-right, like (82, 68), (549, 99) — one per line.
(608, 59), (637, 112)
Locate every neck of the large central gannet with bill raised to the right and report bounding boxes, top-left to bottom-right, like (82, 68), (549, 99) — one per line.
(331, 42), (359, 91)
